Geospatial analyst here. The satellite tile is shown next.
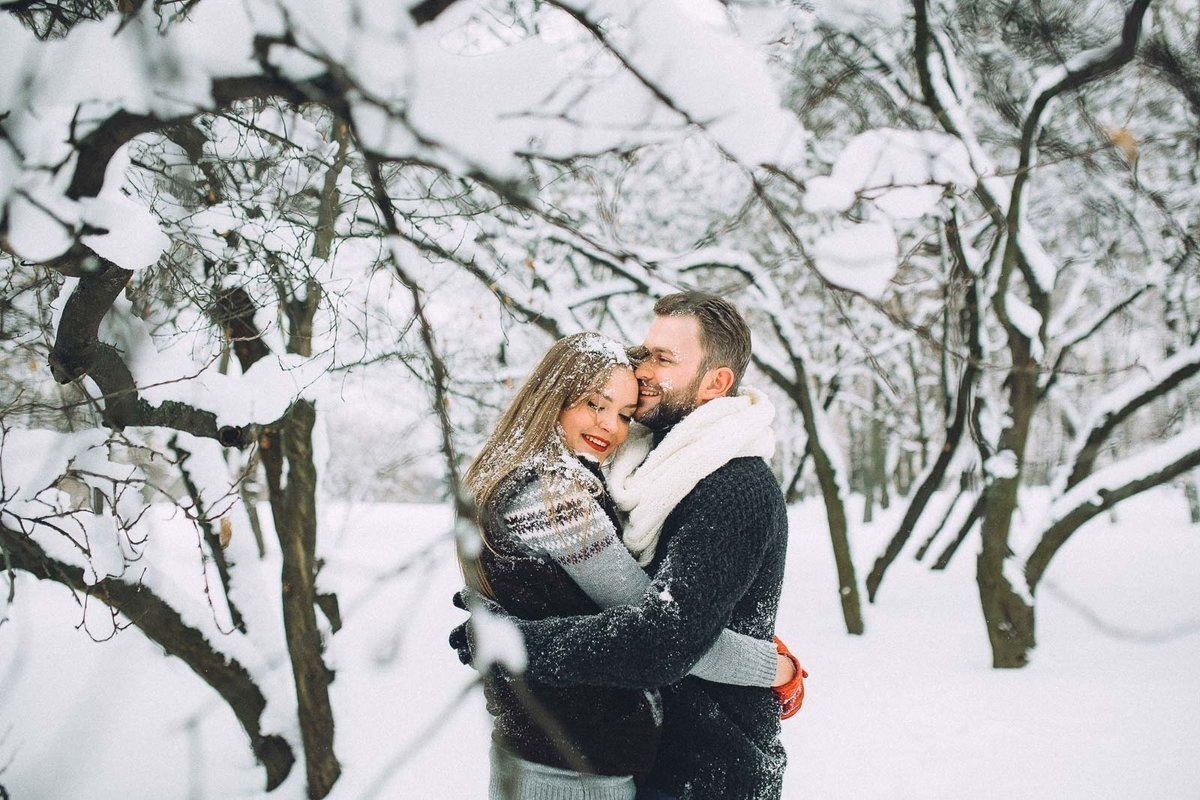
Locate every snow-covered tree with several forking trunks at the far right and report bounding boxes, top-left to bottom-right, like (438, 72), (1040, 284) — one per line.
(798, 1), (1200, 667)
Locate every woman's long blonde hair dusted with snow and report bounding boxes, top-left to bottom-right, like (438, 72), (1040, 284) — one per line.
(464, 333), (632, 513)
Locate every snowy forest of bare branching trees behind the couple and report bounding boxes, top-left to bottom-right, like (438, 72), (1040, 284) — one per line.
(0, 0), (1200, 798)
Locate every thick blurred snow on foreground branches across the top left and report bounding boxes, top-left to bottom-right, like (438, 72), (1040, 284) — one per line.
(0, 0), (804, 270)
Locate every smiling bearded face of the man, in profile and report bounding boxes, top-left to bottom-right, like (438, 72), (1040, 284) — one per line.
(634, 317), (704, 431)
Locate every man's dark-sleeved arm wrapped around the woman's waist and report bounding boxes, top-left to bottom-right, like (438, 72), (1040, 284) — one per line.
(514, 459), (779, 687)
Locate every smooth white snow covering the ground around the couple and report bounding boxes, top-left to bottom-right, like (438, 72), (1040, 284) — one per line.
(0, 493), (1200, 800)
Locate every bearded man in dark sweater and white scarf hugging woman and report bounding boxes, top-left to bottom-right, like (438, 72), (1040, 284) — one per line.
(458, 291), (787, 800)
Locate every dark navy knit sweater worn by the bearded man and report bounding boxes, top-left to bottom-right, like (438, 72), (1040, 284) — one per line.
(517, 458), (787, 800)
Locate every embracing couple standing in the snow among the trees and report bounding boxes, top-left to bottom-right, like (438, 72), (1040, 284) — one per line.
(450, 291), (804, 800)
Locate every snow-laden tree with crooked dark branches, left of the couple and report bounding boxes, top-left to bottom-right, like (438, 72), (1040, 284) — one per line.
(0, 0), (803, 796)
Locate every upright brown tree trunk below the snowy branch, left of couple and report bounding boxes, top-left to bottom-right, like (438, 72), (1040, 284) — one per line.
(260, 401), (342, 800)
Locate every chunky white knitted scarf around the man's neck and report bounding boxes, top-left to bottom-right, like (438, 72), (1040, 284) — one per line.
(606, 386), (775, 566)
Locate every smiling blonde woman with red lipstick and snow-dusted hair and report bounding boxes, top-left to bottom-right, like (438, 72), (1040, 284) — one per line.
(466, 333), (786, 800)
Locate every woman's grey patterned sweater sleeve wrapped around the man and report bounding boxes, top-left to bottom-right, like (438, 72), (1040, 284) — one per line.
(505, 481), (776, 686)
